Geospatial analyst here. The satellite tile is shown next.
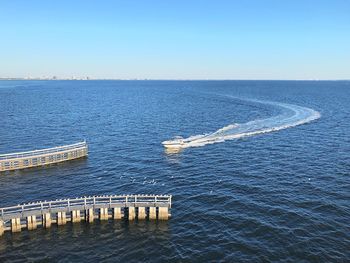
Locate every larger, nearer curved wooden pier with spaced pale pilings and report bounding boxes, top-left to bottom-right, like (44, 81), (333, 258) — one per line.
(0, 195), (172, 236)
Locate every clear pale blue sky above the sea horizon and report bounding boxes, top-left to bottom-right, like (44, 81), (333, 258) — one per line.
(0, 0), (350, 79)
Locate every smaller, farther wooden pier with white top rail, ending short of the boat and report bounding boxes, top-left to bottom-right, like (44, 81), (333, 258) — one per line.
(0, 141), (88, 172)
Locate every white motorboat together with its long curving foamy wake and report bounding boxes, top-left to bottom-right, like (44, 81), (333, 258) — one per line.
(162, 97), (321, 150)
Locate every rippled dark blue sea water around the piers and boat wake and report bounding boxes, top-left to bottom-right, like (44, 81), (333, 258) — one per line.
(0, 81), (350, 262)
